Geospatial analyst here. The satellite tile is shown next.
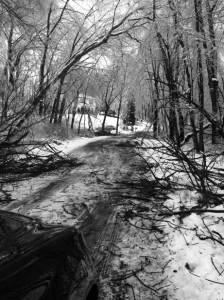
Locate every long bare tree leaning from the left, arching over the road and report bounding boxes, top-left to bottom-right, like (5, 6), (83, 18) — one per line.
(1, 1), (144, 141)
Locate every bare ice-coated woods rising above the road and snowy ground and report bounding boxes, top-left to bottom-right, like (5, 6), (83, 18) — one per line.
(0, 0), (224, 176)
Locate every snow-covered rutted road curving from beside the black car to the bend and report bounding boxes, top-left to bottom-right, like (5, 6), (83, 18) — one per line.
(3, 136), (149, 300)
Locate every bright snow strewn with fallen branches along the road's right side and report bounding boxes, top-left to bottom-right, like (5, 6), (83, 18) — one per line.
(110, 139), (224, 300)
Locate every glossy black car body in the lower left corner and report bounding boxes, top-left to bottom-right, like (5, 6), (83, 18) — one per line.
(0, 211), (98, 300)
